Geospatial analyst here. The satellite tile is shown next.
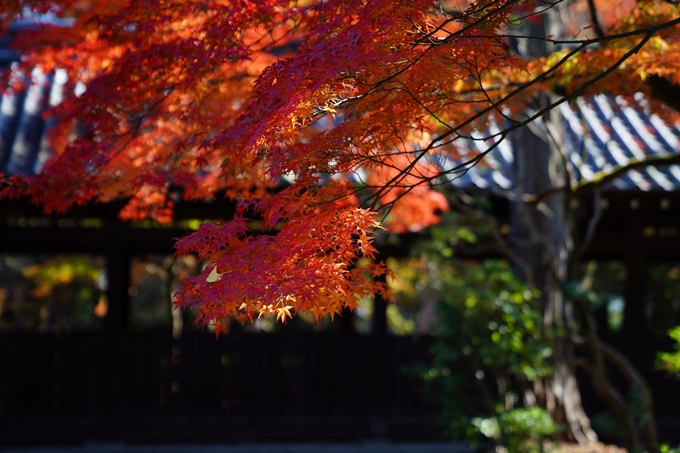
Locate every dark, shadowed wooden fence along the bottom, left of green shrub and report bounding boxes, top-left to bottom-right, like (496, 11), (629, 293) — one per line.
(0, 332), (439, 444)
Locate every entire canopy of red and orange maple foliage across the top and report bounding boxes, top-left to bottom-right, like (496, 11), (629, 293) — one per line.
(0, 0), (680, 327)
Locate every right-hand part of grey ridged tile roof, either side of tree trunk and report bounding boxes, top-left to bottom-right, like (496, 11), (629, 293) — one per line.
(438, 94), (680, 195)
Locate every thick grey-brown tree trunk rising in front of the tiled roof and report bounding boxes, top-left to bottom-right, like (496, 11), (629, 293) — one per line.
(510, 107), (597, 444)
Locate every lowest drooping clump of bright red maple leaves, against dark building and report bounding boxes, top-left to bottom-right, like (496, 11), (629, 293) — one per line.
(177, 187), (390, 332)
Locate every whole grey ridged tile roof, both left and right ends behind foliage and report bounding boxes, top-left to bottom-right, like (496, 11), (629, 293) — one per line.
(0, 61), (680, 195)
